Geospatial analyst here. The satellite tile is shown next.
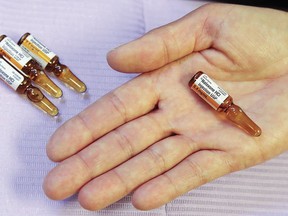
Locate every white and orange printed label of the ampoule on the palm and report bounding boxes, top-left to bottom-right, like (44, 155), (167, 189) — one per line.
(191, 74), (229, 110)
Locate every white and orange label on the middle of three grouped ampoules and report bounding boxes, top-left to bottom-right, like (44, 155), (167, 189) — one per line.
(0, 37), (32, 70)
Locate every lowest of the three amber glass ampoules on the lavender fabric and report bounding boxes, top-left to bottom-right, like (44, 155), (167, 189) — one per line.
(0, 57), (59, 116)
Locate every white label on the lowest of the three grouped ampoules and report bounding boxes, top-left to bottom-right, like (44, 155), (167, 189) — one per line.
(0, 58), (24, 91)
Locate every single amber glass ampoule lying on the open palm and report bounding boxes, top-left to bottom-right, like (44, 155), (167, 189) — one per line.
(189, 71), (261, 136)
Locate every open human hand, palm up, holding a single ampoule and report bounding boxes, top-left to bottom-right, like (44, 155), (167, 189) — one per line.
(43, 4), (288, 210)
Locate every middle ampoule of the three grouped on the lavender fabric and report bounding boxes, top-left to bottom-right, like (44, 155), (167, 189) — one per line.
(0, 35), (62, 98)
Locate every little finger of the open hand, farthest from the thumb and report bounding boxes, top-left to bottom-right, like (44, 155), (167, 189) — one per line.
(132, 150), (235, 210)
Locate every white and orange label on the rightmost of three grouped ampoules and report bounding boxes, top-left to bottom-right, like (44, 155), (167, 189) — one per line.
(20, 35), (56, 68)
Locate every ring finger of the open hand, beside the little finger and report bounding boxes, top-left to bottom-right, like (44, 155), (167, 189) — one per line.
(78, 135), (199, 210)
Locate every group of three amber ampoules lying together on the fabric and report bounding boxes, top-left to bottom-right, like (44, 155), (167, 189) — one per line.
(0, 33), (86, 116)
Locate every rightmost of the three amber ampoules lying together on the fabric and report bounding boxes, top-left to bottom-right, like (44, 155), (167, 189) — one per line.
(18, 33), (87, 93)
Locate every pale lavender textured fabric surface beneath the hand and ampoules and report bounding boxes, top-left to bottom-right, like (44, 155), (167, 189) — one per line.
(0, 0), (288, 216)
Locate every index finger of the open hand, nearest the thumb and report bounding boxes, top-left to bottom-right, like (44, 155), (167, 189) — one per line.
(47, 74), (158, 161)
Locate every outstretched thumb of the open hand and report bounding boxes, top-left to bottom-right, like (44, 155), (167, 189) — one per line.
(107, 3), (215, 72)
